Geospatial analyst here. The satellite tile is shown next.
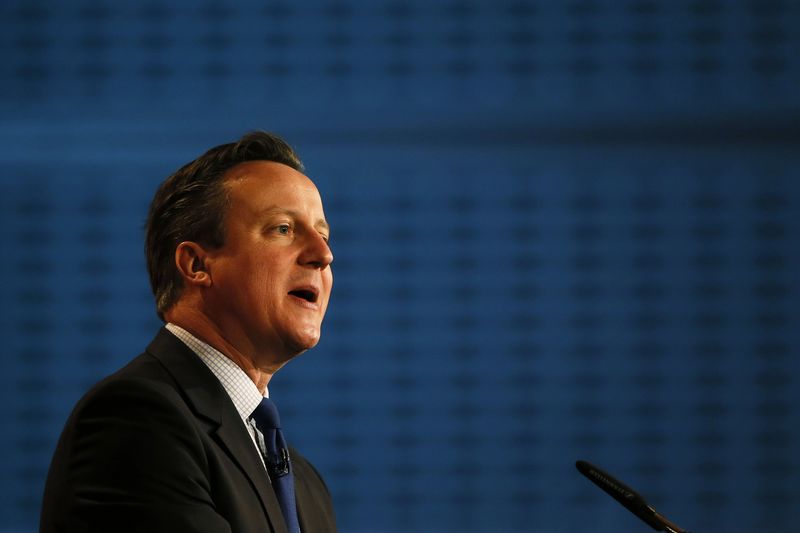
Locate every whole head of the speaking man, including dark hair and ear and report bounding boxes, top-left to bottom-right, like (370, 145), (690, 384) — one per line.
(146, 133), (333, 366)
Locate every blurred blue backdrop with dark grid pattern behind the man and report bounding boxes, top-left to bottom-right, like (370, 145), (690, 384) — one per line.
(0, 0), (800, 533)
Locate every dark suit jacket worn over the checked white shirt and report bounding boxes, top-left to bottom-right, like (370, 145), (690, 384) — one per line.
(40, 329), (336, 533)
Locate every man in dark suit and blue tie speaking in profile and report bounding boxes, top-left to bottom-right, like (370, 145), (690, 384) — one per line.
(41, 132), (335, 533)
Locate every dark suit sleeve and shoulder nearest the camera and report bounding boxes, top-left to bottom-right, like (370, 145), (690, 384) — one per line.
(41, 354), (236, 532)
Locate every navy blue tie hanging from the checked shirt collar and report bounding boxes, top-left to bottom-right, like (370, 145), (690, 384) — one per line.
(252, 398), (300, 533)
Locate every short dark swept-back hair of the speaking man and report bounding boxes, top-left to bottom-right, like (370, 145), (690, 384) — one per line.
(145, 131), (303, 320)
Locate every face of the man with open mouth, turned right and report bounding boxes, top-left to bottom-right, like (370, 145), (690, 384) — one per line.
(205, 161), (333, 366)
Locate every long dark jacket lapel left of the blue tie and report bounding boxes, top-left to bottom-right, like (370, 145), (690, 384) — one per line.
(147, 328), (287, 533)
